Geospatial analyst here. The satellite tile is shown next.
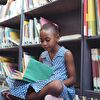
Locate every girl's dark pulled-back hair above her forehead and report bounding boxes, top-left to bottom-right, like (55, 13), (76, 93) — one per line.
(40, 22), (60, 35)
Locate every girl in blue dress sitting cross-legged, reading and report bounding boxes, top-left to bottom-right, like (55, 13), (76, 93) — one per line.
(2, 23), (76, 100)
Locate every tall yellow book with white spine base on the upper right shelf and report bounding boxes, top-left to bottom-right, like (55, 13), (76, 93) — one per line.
(88, 0), (97, 36)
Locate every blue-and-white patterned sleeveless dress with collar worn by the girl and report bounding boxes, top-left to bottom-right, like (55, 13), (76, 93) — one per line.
(6, 47), (75, 100)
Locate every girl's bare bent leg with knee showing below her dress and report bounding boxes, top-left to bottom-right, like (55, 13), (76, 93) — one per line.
(27, 80), (63, 100)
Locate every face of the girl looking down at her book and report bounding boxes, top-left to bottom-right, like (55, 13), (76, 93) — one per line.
(40, 30), (58, 52)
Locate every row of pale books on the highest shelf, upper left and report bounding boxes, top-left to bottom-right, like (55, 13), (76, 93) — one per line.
(0, 0), (56, 21)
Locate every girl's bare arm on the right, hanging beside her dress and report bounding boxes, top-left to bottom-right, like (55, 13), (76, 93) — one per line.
(64, 51), (76, 86)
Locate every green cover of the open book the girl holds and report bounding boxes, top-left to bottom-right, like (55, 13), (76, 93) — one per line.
(23, 57), (53, 82)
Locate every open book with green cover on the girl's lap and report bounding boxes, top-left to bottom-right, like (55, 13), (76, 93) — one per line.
(2, 54), (53, 82)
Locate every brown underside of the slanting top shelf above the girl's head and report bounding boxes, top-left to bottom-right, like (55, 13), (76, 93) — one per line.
(25, 0), (81, 17)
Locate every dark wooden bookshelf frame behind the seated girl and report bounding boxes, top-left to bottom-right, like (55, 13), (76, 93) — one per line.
(0, 0), (100, 99)
